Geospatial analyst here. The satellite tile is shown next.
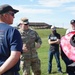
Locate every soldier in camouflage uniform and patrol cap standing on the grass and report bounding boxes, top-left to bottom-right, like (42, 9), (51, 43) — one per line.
(19, 18), (42, 75)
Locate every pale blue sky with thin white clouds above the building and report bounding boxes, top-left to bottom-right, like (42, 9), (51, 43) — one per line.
(0, 0), (75, 28)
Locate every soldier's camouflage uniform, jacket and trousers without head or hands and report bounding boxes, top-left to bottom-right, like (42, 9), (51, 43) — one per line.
(19, 29), (42, 75)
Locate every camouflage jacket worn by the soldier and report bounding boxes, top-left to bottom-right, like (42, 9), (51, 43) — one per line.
(19, 29), (42, 59)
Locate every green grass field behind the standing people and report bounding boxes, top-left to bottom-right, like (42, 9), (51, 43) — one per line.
(20, 29), (66, 75)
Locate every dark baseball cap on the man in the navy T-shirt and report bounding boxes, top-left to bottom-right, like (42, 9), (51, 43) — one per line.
(0, 4), (19, 14)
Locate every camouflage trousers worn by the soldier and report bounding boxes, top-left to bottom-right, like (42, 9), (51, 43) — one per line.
(21, 58), (41, 75)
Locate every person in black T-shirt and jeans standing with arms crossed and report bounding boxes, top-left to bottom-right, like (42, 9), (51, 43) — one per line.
(48, 26), (62, 74)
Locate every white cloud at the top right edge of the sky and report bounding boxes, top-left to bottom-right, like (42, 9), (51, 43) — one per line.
(38, 0), (75, 7)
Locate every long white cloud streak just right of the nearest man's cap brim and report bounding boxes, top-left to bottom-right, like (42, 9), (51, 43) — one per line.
(12, 5), (52, 14)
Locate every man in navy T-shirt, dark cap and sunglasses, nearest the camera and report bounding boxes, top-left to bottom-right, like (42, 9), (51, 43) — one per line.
(0, 4), (23, 75)
